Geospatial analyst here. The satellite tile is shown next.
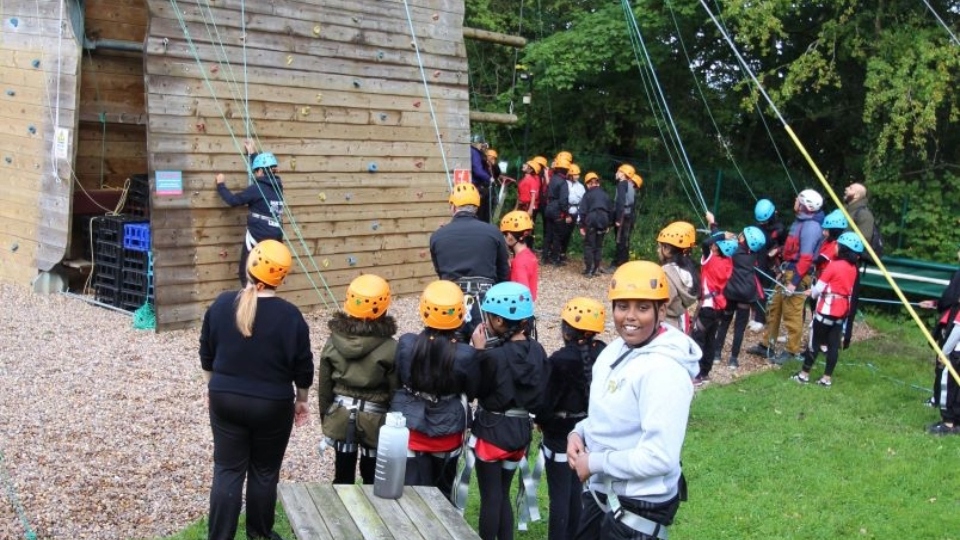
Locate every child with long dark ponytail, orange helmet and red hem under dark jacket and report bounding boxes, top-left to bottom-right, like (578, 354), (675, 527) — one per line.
(390, 280), (480, 500)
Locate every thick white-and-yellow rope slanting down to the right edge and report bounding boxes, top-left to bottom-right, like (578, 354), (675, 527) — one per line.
(700, 0), (960, 384)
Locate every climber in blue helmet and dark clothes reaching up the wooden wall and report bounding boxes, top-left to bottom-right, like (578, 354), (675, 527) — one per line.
(216, 141), (284, 287)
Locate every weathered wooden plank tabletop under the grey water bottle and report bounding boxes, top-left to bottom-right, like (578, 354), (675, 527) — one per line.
(279, 482), (480, 540)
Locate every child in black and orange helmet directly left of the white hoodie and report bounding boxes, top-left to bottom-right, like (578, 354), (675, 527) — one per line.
(536, 297), (607, 540)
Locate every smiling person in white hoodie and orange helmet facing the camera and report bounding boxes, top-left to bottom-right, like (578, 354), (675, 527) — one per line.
(567, 261), (701, 540)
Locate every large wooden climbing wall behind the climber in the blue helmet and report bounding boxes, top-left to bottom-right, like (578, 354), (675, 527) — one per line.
(144, 0), (470, 329)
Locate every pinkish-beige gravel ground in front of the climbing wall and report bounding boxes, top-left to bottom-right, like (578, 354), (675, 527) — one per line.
(0, 262), (872, 540)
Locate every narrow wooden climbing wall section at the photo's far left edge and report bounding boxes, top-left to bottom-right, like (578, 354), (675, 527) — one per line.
(0, 0), (80, 285)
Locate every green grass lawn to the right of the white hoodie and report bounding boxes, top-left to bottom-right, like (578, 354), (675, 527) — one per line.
(158, 317), (960, 540)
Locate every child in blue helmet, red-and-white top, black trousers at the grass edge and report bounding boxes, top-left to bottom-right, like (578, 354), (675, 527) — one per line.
(790, 232), (863, 386)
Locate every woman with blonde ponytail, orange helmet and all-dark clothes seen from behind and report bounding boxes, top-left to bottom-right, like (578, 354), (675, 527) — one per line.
(200, 240), (313, 540)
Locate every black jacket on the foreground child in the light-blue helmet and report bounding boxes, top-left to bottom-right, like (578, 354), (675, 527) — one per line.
(473, 339), (550, 451)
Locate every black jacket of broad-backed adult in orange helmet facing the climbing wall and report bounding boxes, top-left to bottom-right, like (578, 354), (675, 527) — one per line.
(430, 212), (510, 283)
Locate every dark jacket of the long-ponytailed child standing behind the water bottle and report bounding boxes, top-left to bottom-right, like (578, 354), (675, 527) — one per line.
(390, 334), (480, 437)
